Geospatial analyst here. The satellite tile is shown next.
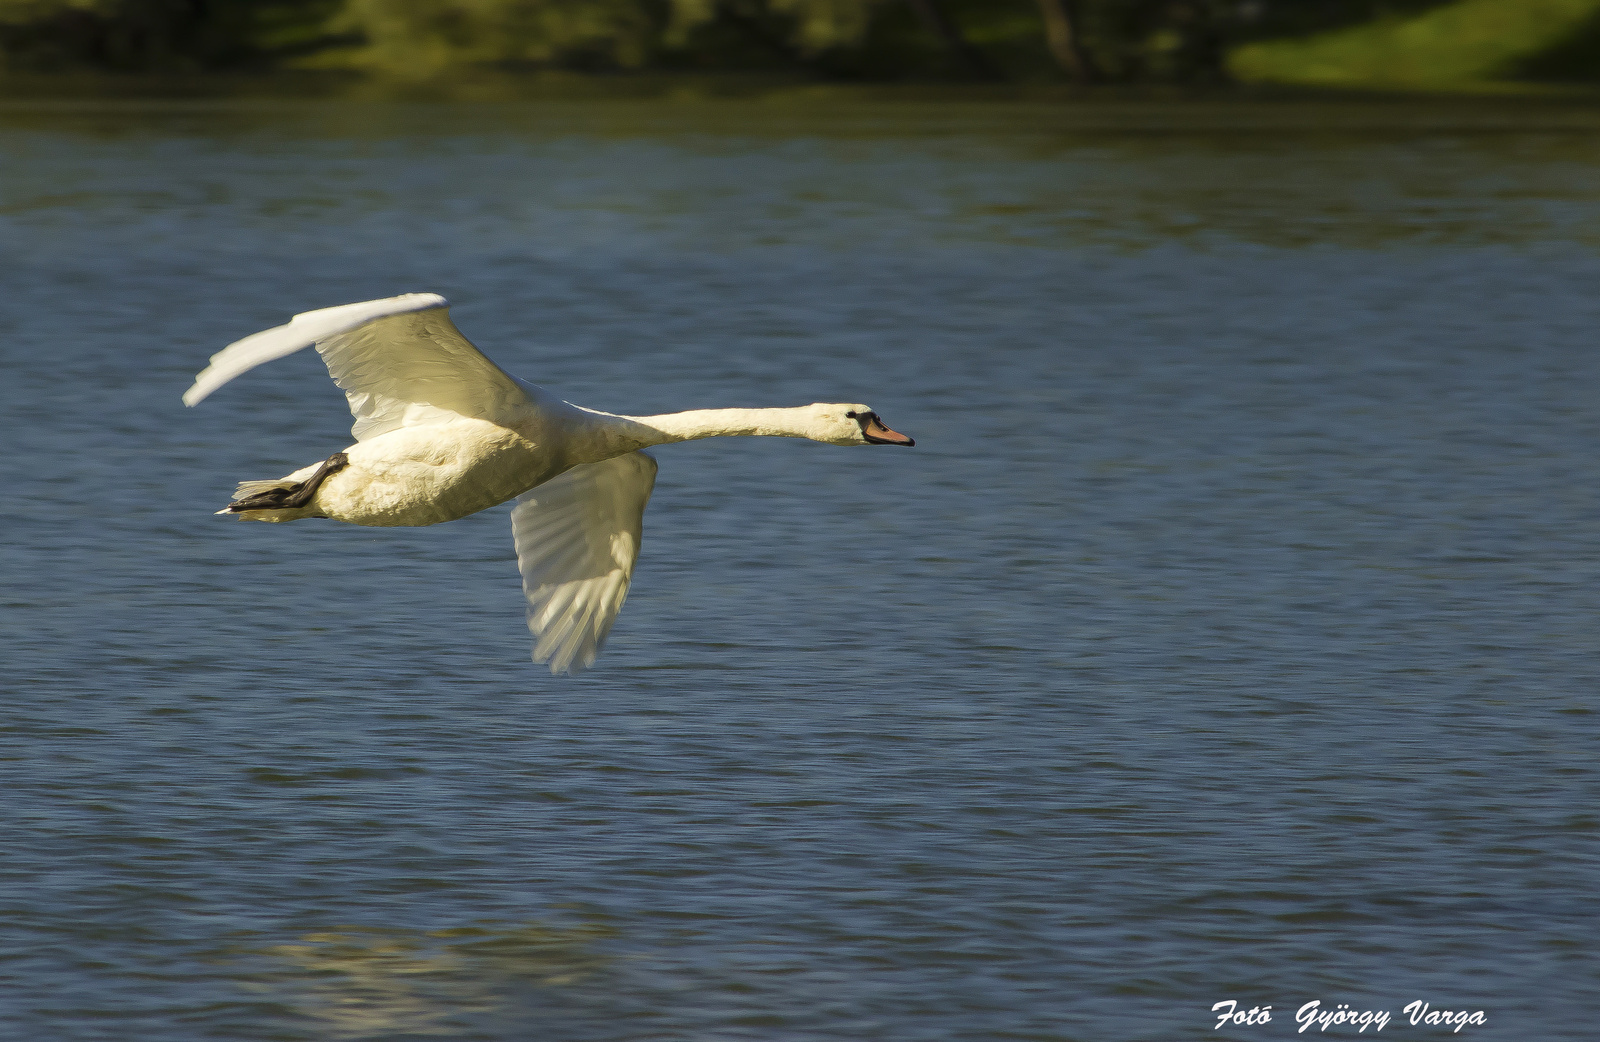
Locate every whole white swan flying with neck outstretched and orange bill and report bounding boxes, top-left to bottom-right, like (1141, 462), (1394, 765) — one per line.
(184, 293), (915, 674)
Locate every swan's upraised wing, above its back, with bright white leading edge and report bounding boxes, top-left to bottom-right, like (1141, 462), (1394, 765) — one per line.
(184, 293), (528, 440)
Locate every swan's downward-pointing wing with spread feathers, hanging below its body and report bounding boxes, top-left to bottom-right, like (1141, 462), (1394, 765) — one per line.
(510, 453), (656, 674)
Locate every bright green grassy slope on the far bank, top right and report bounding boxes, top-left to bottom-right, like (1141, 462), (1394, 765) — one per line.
(1229, 0), (1600, 90)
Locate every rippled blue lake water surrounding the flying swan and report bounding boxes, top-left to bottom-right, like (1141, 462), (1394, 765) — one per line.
(0, 101), (1600, 1042)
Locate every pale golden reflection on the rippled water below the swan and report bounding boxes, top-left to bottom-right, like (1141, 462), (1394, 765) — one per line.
(232, 924), (611, 1037)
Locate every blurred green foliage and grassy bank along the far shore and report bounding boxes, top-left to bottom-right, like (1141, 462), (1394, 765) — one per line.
(0, 0), (1600, 88)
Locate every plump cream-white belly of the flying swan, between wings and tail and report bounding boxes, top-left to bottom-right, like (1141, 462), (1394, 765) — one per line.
(314, 418), (562, 525)
